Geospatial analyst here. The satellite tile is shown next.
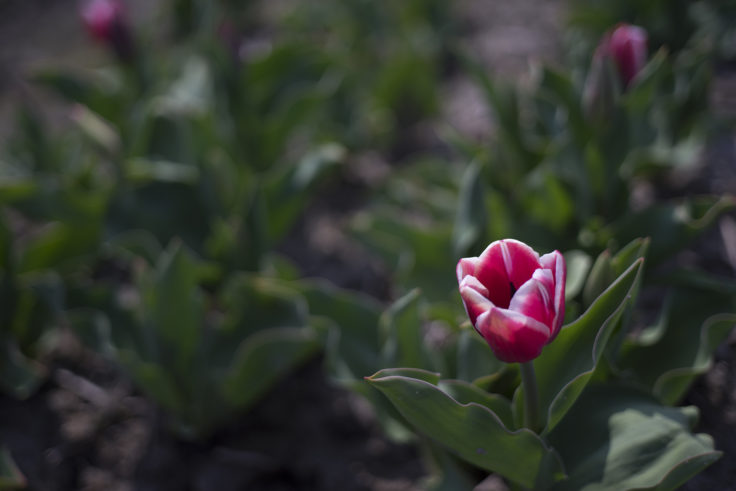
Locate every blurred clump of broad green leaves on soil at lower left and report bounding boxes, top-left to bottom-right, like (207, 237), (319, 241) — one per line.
(77, 243), (319, 438)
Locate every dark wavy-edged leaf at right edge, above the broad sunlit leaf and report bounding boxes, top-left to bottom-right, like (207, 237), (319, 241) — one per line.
(618, 288), (736, 404)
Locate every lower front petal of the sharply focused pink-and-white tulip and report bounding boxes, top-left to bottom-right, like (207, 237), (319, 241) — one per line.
(476, 307), (549, 363)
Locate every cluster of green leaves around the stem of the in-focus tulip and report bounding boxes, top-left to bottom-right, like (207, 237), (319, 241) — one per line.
(367, 240), (736, 490)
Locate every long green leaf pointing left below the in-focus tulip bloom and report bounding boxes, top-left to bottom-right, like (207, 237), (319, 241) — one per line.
(367, 371), (564, 489)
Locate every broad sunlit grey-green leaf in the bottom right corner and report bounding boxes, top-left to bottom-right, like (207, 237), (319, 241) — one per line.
(548, 384), (720, 491)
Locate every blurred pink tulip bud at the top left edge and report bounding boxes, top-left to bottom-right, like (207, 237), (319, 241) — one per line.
(81, 0), (134, 62)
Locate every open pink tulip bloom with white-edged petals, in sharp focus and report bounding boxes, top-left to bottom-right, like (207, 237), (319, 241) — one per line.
(457, 239), (566, 363)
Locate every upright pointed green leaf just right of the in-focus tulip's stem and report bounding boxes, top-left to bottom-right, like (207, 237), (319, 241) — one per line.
(534, 259), (643, 431)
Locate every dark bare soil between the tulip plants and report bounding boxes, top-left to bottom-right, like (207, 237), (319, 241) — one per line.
(0, 0), (736, 491)
